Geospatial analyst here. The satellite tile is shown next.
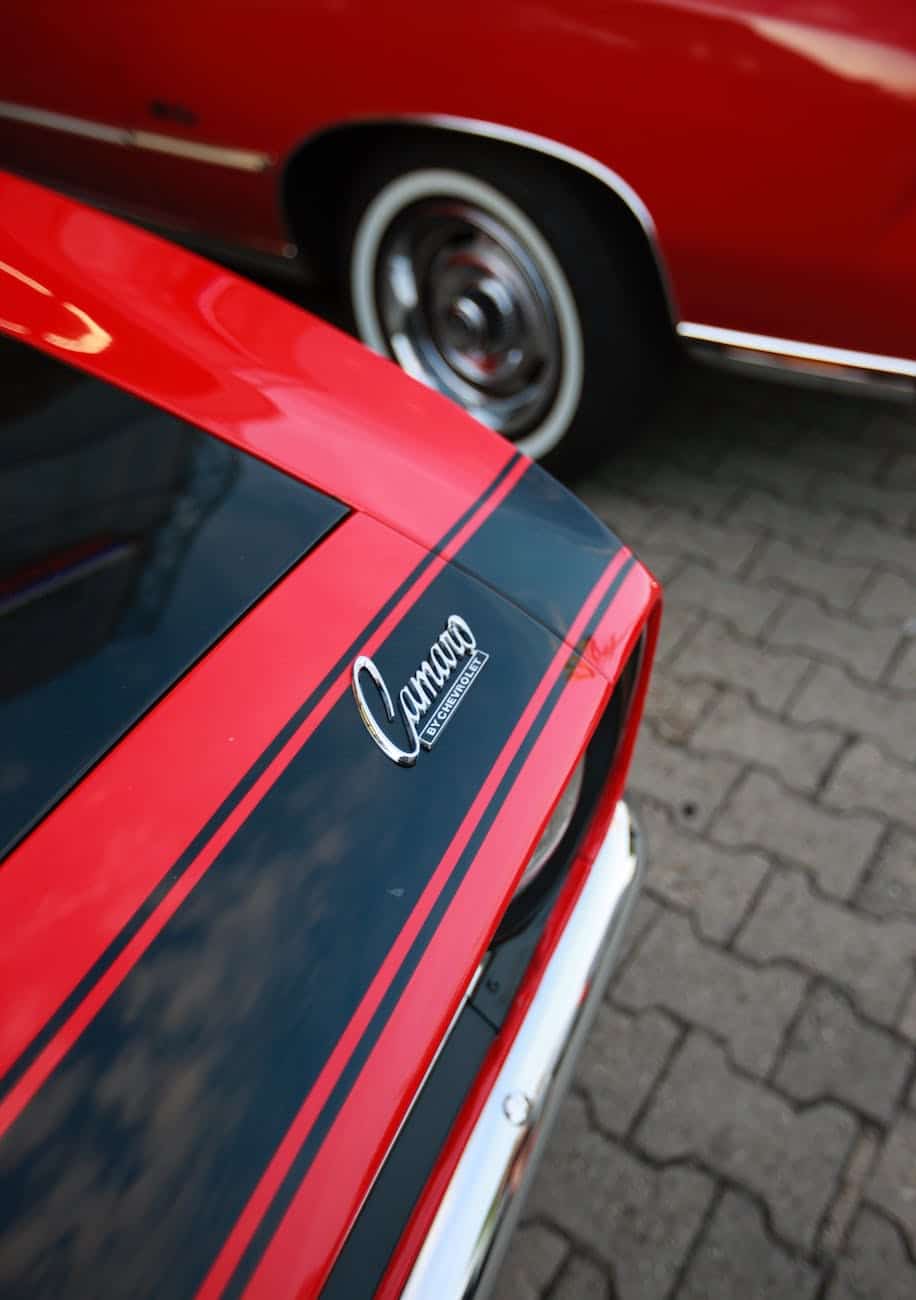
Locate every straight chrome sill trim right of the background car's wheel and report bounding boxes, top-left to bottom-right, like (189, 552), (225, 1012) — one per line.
(677, 321), (916, 397)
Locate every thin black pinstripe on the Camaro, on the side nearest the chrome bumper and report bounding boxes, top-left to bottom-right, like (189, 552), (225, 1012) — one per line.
(223, 556), (635, 1300)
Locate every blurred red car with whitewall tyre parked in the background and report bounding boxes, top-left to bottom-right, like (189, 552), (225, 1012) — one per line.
(0, 0), (916, 463)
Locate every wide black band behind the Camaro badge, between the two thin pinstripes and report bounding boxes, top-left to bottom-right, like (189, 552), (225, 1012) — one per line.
(0, 462), (616, 1300)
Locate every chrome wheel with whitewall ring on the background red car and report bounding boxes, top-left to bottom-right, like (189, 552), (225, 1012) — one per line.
(351, 169), (583, 456)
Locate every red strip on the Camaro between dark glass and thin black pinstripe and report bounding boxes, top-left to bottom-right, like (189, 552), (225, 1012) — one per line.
(0, 515), (420, 1132)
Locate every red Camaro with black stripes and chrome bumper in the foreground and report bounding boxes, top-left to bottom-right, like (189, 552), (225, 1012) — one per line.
(0, 177), (660, 1300)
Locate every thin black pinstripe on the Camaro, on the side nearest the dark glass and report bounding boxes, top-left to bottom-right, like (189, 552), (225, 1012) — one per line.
(0, 452), (520, 1101)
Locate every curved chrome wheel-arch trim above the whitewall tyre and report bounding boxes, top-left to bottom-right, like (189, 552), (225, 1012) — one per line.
(294, 113), (680, 324)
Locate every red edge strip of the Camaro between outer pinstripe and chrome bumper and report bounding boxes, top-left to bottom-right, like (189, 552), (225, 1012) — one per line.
(237, 556), (657, 1300)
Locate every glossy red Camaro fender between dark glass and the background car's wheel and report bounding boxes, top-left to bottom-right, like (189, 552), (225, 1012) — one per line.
(0, 174), (512, 546)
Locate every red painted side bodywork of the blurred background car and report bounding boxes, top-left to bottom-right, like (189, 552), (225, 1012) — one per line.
(0, 0), (916, 359)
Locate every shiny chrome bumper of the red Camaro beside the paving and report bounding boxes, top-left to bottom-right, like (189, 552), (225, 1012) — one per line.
(401, 801), (643, 1300)
